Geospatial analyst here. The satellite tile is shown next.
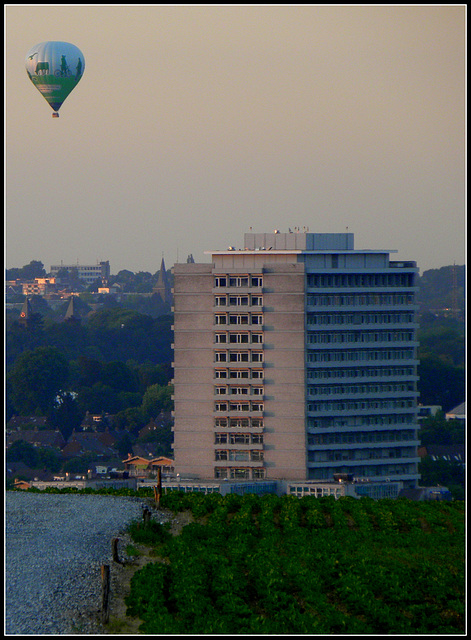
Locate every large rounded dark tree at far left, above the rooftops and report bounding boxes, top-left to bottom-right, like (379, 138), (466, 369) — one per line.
(9, 347), (70, 415)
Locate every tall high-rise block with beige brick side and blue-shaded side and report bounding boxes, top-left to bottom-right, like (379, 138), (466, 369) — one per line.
(174, 230), (419, 487)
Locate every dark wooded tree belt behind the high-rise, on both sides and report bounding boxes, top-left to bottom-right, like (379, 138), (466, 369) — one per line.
(5, 261), (465, 448)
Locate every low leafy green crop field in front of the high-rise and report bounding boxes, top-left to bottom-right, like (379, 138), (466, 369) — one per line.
(126, 492), (465, 635)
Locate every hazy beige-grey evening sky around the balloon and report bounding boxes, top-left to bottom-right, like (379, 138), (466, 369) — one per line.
(5, 5), (466, 274)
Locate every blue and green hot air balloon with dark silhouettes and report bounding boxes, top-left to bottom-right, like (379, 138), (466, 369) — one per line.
(25, 42), (85, 118)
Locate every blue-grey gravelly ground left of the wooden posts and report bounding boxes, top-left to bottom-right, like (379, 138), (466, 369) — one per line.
(5, 491), (153, 635)
